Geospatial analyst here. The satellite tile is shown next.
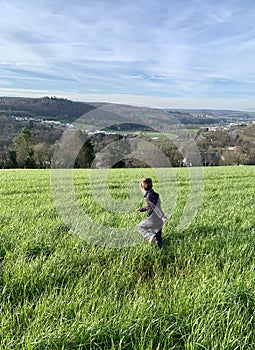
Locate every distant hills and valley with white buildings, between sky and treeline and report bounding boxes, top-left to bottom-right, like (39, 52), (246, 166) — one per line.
(0, 96), (255, 147)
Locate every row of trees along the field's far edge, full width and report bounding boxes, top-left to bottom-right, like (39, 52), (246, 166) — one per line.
(0, 125), (255, 168)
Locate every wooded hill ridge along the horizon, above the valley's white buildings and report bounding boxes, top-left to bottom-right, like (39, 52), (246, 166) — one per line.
(0, 96), (255, 128)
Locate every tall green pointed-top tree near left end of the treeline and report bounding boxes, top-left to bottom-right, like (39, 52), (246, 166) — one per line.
(13, 128), (35, 168)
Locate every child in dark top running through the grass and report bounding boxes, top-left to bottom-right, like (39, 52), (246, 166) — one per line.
(136, 178), (167, 248)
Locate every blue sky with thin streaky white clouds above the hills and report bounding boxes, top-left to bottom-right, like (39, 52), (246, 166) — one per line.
(0, 0), (255, 111)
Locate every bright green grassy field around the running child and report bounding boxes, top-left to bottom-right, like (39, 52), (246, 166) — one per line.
(0, 167), (255, 350)
